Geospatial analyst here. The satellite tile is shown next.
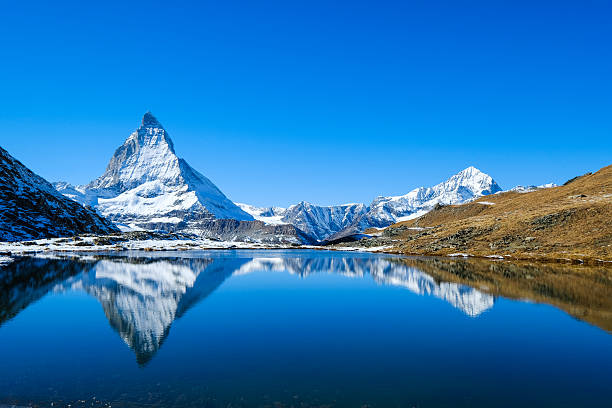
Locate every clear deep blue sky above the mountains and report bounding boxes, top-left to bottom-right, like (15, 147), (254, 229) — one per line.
(0, 0), (612, 206)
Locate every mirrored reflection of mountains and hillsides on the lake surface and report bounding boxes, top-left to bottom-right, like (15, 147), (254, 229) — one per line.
(0, 251), (612, 365)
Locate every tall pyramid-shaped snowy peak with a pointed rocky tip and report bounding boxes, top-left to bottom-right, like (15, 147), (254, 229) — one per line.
(55, 112), (253, 232)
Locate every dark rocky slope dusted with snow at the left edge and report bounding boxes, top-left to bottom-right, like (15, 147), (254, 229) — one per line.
(0, 147), (117, 241)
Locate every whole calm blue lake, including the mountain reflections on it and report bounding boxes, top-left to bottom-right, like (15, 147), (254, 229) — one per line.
(0, 251), (612, 407)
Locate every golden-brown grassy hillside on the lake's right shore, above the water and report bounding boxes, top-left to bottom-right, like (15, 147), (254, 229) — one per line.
(382, 166), (612, 263)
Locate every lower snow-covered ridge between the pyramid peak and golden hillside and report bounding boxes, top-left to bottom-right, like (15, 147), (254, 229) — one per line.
(237, 167), (501, 241)
